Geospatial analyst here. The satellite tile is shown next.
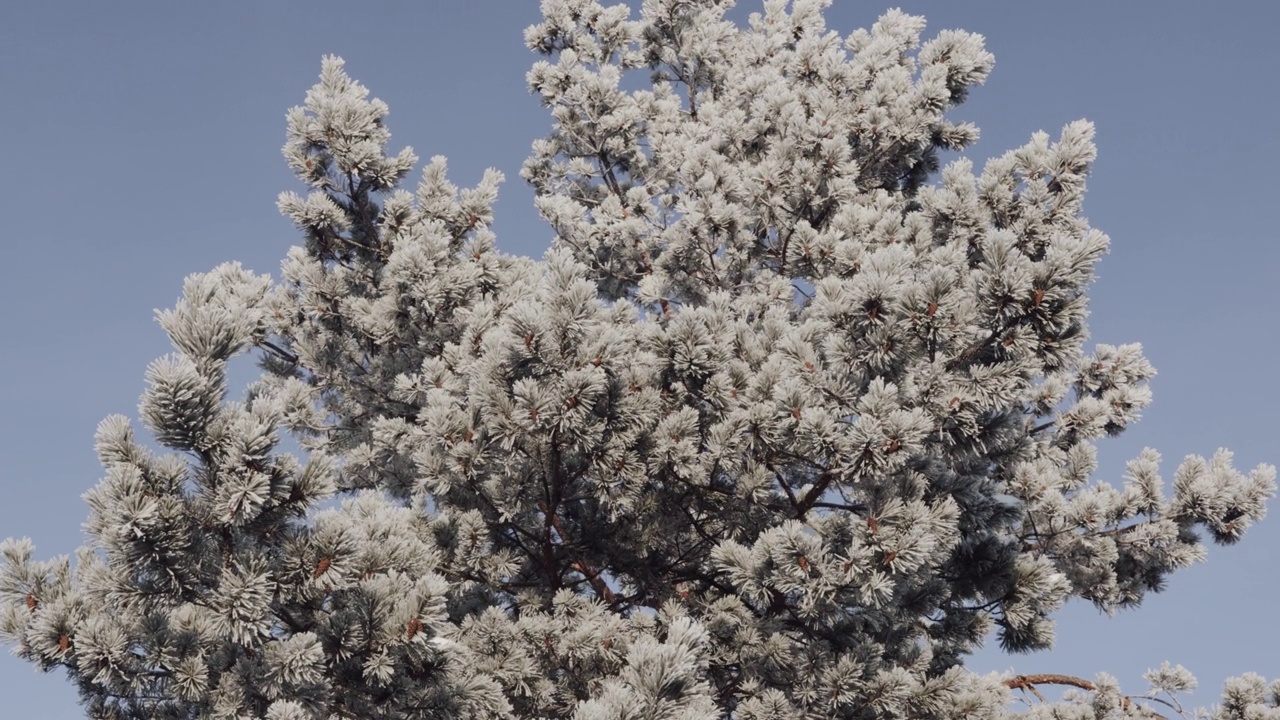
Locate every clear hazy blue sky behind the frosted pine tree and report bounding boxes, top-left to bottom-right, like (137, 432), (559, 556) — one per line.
(0, 0), (1280, 720)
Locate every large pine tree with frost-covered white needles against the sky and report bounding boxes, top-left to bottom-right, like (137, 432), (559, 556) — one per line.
(0, 0), (1280, 720)
